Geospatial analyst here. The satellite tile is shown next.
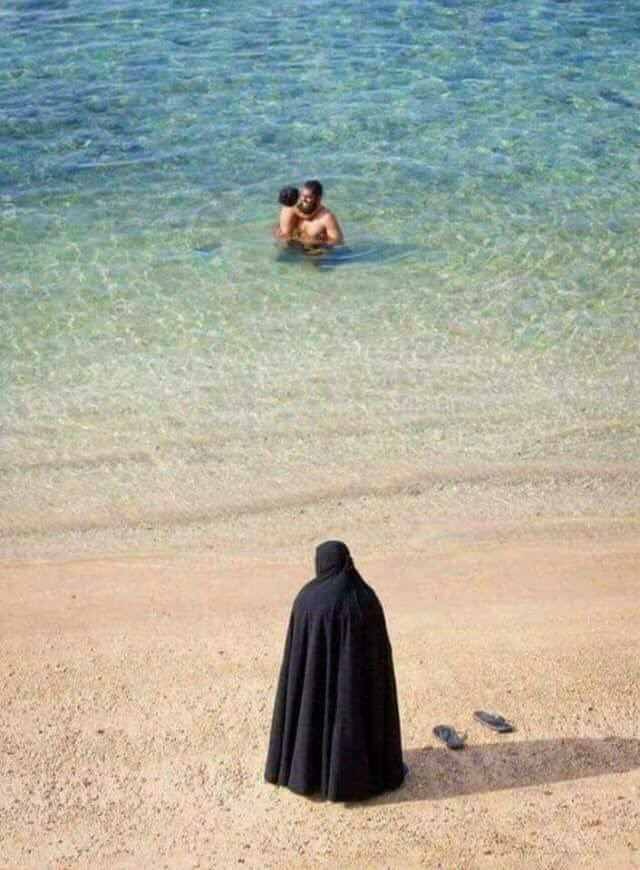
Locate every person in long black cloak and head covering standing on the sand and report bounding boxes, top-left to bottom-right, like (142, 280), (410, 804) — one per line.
(265, 541), (405, 801)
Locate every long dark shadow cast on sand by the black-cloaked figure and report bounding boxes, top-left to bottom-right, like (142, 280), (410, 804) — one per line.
(353, 737), (640, 806)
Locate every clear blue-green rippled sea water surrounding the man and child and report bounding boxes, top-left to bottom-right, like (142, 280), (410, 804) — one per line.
(0, 0), (640, 534)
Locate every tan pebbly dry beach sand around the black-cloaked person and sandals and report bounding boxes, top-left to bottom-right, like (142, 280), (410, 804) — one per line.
(0, 493), (640, 870)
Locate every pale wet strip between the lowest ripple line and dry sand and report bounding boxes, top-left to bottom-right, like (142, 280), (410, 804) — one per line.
(0, 461), (640, 560)
